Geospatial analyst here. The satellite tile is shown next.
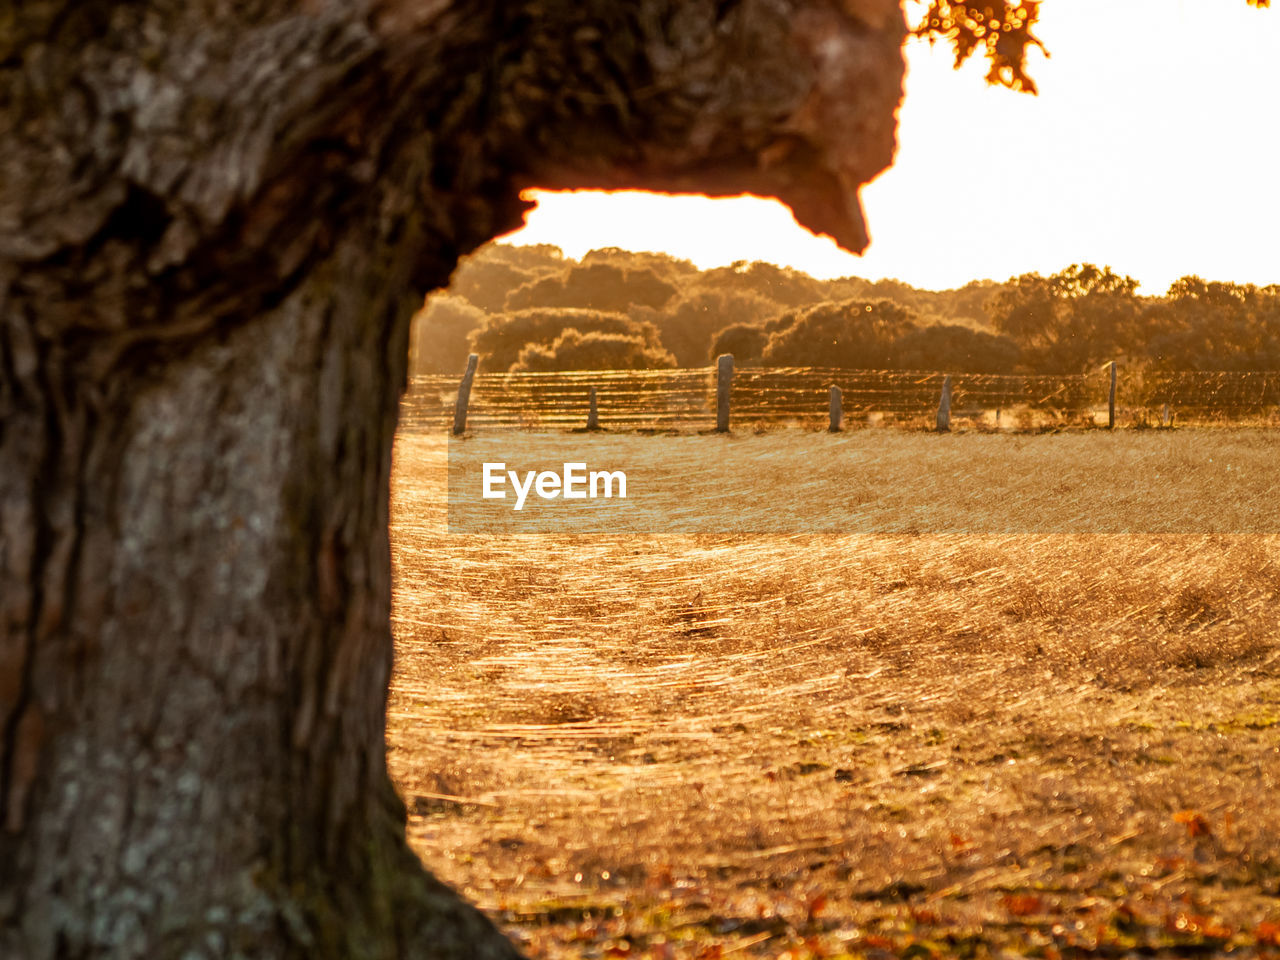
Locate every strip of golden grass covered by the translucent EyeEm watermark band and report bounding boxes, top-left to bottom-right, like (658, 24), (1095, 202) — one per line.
(445, 429), (1280, 535)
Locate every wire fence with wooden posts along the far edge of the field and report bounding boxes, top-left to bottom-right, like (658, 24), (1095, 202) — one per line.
(401, 362), (1280, 430)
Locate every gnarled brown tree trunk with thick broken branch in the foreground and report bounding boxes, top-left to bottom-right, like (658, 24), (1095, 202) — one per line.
(0, 0), (904, 960)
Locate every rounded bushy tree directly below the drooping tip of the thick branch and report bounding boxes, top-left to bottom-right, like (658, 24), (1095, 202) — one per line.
(762, 300), (916, 370)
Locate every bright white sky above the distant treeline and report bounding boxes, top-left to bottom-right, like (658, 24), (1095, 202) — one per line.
(506, 0), (1280, 293)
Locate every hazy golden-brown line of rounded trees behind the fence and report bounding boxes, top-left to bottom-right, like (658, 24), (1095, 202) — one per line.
(412, 243), (1280, 374)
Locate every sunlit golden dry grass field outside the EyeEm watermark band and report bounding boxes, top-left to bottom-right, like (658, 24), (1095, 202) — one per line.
(388, 430), (1280, 960)
